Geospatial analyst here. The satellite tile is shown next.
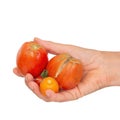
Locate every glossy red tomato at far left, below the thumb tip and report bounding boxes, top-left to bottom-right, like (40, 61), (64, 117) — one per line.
(16, 41), (48, 77)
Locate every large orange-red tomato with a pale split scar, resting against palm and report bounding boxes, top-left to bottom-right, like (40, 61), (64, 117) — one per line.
(46, 53), (83, 90)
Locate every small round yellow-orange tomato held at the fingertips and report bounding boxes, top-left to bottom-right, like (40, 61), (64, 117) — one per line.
(40, 77), (59, 96)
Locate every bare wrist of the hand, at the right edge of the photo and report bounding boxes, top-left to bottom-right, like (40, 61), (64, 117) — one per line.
(104, 52), (120, 86)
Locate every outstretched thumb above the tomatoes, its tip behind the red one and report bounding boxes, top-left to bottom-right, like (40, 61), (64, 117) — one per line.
(34, 38), (70, 54)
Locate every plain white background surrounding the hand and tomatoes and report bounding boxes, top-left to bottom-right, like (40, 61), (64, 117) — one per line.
(0, 0), (120, 120)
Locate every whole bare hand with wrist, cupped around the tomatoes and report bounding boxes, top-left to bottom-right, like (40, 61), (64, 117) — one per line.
(13, 38), (120, 102)
